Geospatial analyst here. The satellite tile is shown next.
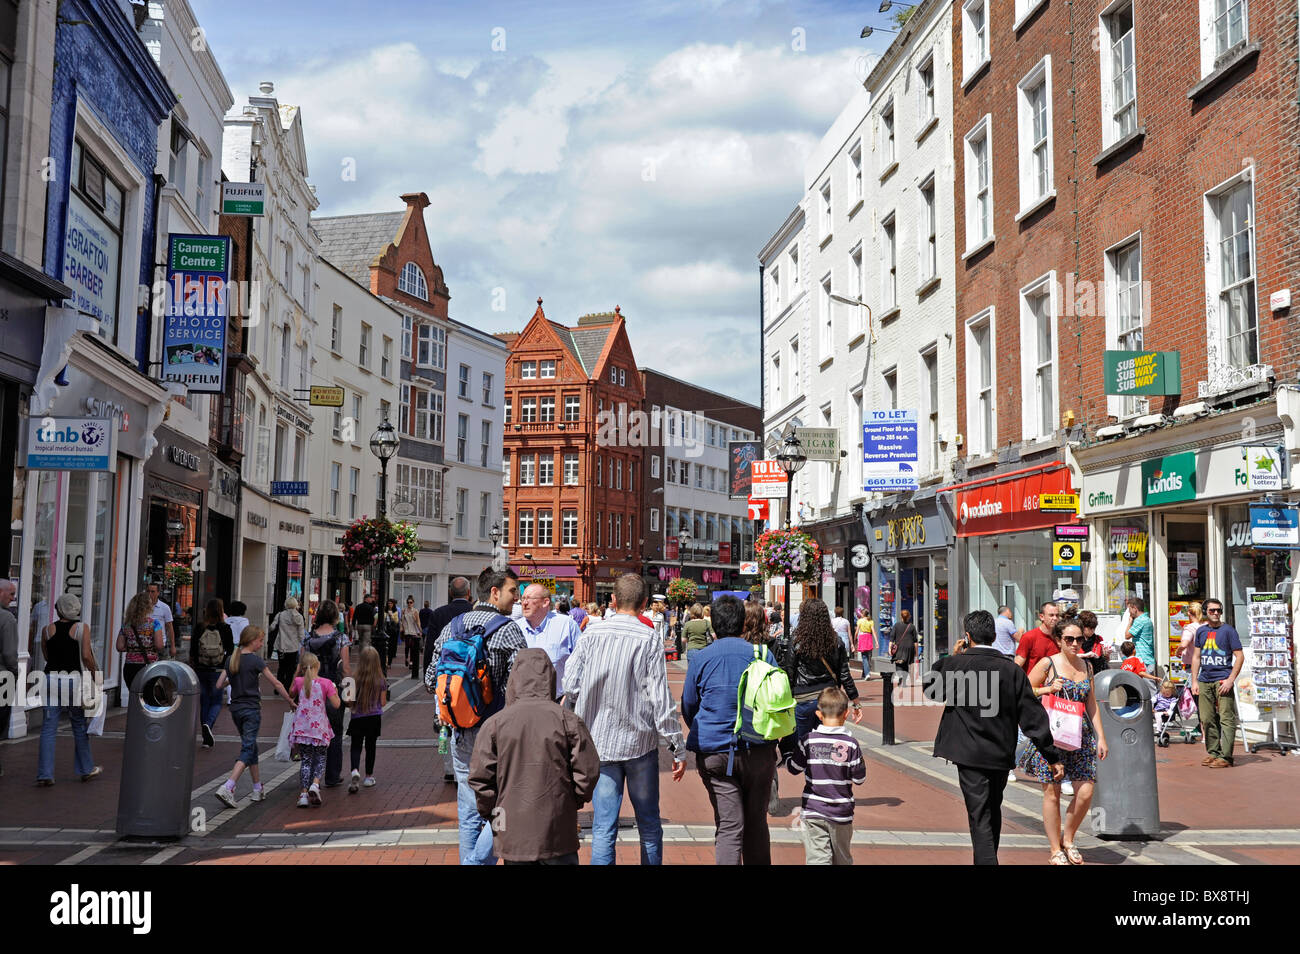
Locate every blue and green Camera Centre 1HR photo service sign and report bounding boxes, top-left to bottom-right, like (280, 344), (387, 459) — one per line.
(161, 235), (230, 394)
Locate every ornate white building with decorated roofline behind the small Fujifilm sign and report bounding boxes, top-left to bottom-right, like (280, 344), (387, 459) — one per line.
(221, 83), (320, 621)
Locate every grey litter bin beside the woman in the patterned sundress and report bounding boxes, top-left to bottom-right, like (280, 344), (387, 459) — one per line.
(1091, 669), (1160, 838)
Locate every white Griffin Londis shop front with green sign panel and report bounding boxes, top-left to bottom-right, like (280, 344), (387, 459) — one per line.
(1074, 403), (1295, 669)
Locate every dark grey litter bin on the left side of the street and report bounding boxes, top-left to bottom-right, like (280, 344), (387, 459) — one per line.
(117, 659), (199, 838)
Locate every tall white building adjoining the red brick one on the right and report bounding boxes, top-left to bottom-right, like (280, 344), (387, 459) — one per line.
(759, 0), (958, 645)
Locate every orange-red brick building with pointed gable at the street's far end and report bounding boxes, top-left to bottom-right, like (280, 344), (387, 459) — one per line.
(501, 299), (645, 602)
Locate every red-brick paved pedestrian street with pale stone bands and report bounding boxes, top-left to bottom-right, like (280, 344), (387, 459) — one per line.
(0, 663), (1300, 864)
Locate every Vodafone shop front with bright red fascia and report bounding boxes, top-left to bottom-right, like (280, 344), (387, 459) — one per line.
(946, 461), (1091, 629)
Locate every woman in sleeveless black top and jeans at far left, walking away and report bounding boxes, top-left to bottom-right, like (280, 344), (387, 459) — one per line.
(36, 593), (104, 786)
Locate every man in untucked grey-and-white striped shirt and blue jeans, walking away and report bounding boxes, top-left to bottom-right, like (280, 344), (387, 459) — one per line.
(564, 573), (686, 864)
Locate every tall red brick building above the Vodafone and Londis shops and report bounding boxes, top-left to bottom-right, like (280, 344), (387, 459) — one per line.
(953, 0), (1300, 662)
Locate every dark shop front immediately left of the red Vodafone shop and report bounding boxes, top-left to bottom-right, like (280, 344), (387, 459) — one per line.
(863, 491), (953, 669)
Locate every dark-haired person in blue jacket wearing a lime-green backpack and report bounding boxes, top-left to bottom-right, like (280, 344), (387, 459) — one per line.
(681, 597), (776, 864)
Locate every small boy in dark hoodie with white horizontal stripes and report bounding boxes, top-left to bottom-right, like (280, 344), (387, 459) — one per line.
(787, 686), (867, 864)
